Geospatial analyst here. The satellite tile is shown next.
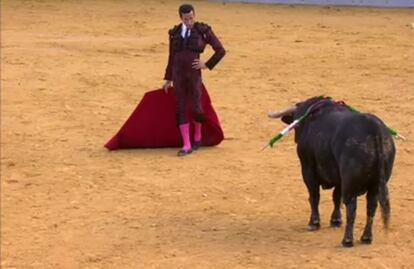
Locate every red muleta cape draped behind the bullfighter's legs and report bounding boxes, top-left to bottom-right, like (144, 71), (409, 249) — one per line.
(105, 85), (224, 150)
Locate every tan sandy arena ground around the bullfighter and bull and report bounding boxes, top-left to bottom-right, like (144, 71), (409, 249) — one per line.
(1, 0), (414, 268)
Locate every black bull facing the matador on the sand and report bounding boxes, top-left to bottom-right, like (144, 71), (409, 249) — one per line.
(269, 97), (395, 247)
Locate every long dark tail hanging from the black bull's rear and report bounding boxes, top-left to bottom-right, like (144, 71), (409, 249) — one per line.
(377, 137), (391, 229)
